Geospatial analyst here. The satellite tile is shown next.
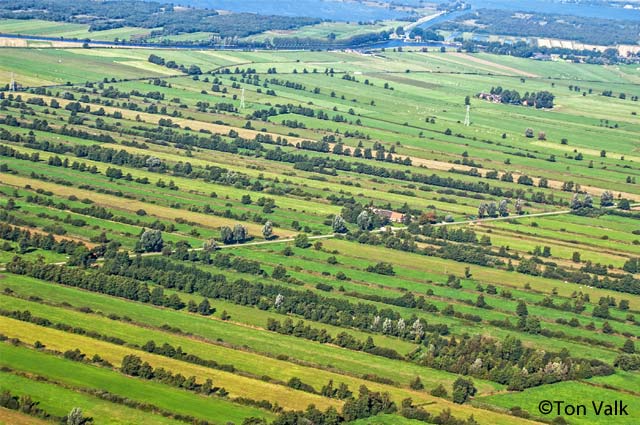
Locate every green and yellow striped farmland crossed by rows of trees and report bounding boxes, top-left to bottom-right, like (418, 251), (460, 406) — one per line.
(0, 44), (640, 425)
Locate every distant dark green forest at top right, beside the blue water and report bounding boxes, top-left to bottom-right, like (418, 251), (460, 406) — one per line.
(438, 9), (640, 45)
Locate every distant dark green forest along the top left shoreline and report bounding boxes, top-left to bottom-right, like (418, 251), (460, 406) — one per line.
(0, 0), (321, 37)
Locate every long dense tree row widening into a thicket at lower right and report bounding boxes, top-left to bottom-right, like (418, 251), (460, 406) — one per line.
(7, 255), (611, 388)
